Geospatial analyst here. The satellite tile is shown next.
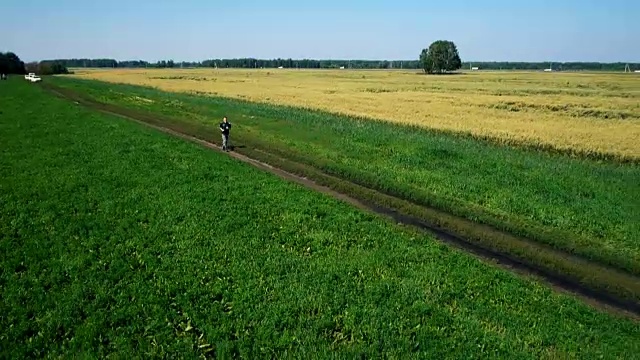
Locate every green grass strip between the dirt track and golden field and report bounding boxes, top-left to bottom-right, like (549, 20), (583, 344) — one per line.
(51, 78), (640, 275)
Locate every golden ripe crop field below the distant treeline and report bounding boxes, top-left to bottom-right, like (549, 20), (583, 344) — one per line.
(66, 69), (640, 159)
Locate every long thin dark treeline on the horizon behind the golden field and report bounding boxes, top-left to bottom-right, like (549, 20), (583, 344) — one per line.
(46, 58), (640, 71)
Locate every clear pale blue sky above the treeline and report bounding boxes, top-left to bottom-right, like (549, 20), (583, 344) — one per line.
(0, 0), (640, 62)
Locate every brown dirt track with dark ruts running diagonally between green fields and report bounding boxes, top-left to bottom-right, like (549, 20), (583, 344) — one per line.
(43, 84), (640, 319)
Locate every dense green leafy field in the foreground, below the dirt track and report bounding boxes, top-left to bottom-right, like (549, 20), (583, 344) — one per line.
(0, 79), (640, 359)
